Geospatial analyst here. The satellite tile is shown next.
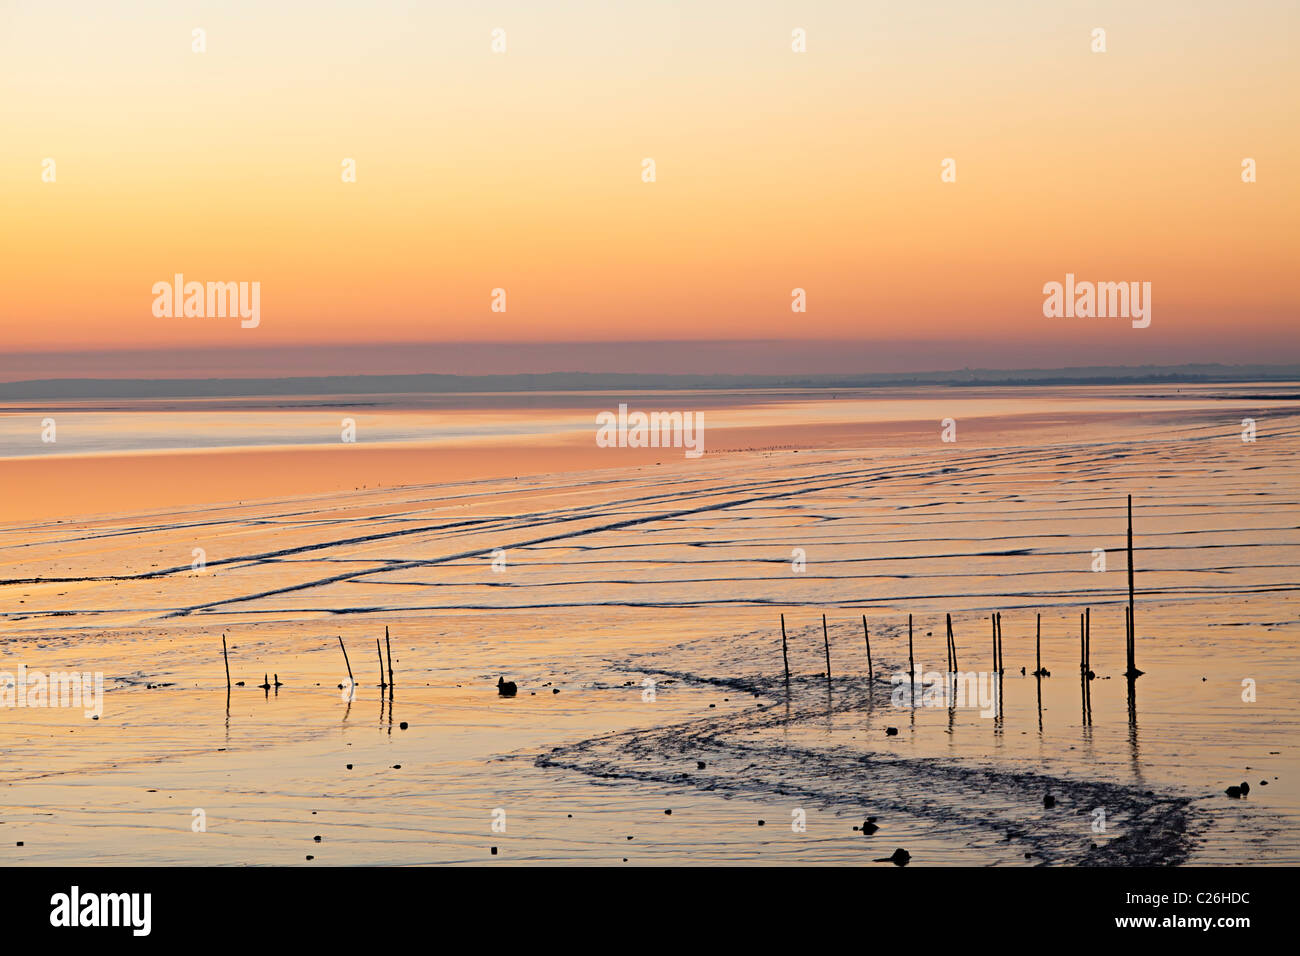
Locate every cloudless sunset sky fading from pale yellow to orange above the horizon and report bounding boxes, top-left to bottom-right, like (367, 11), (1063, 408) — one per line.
(0, 0), (1300, 375)
